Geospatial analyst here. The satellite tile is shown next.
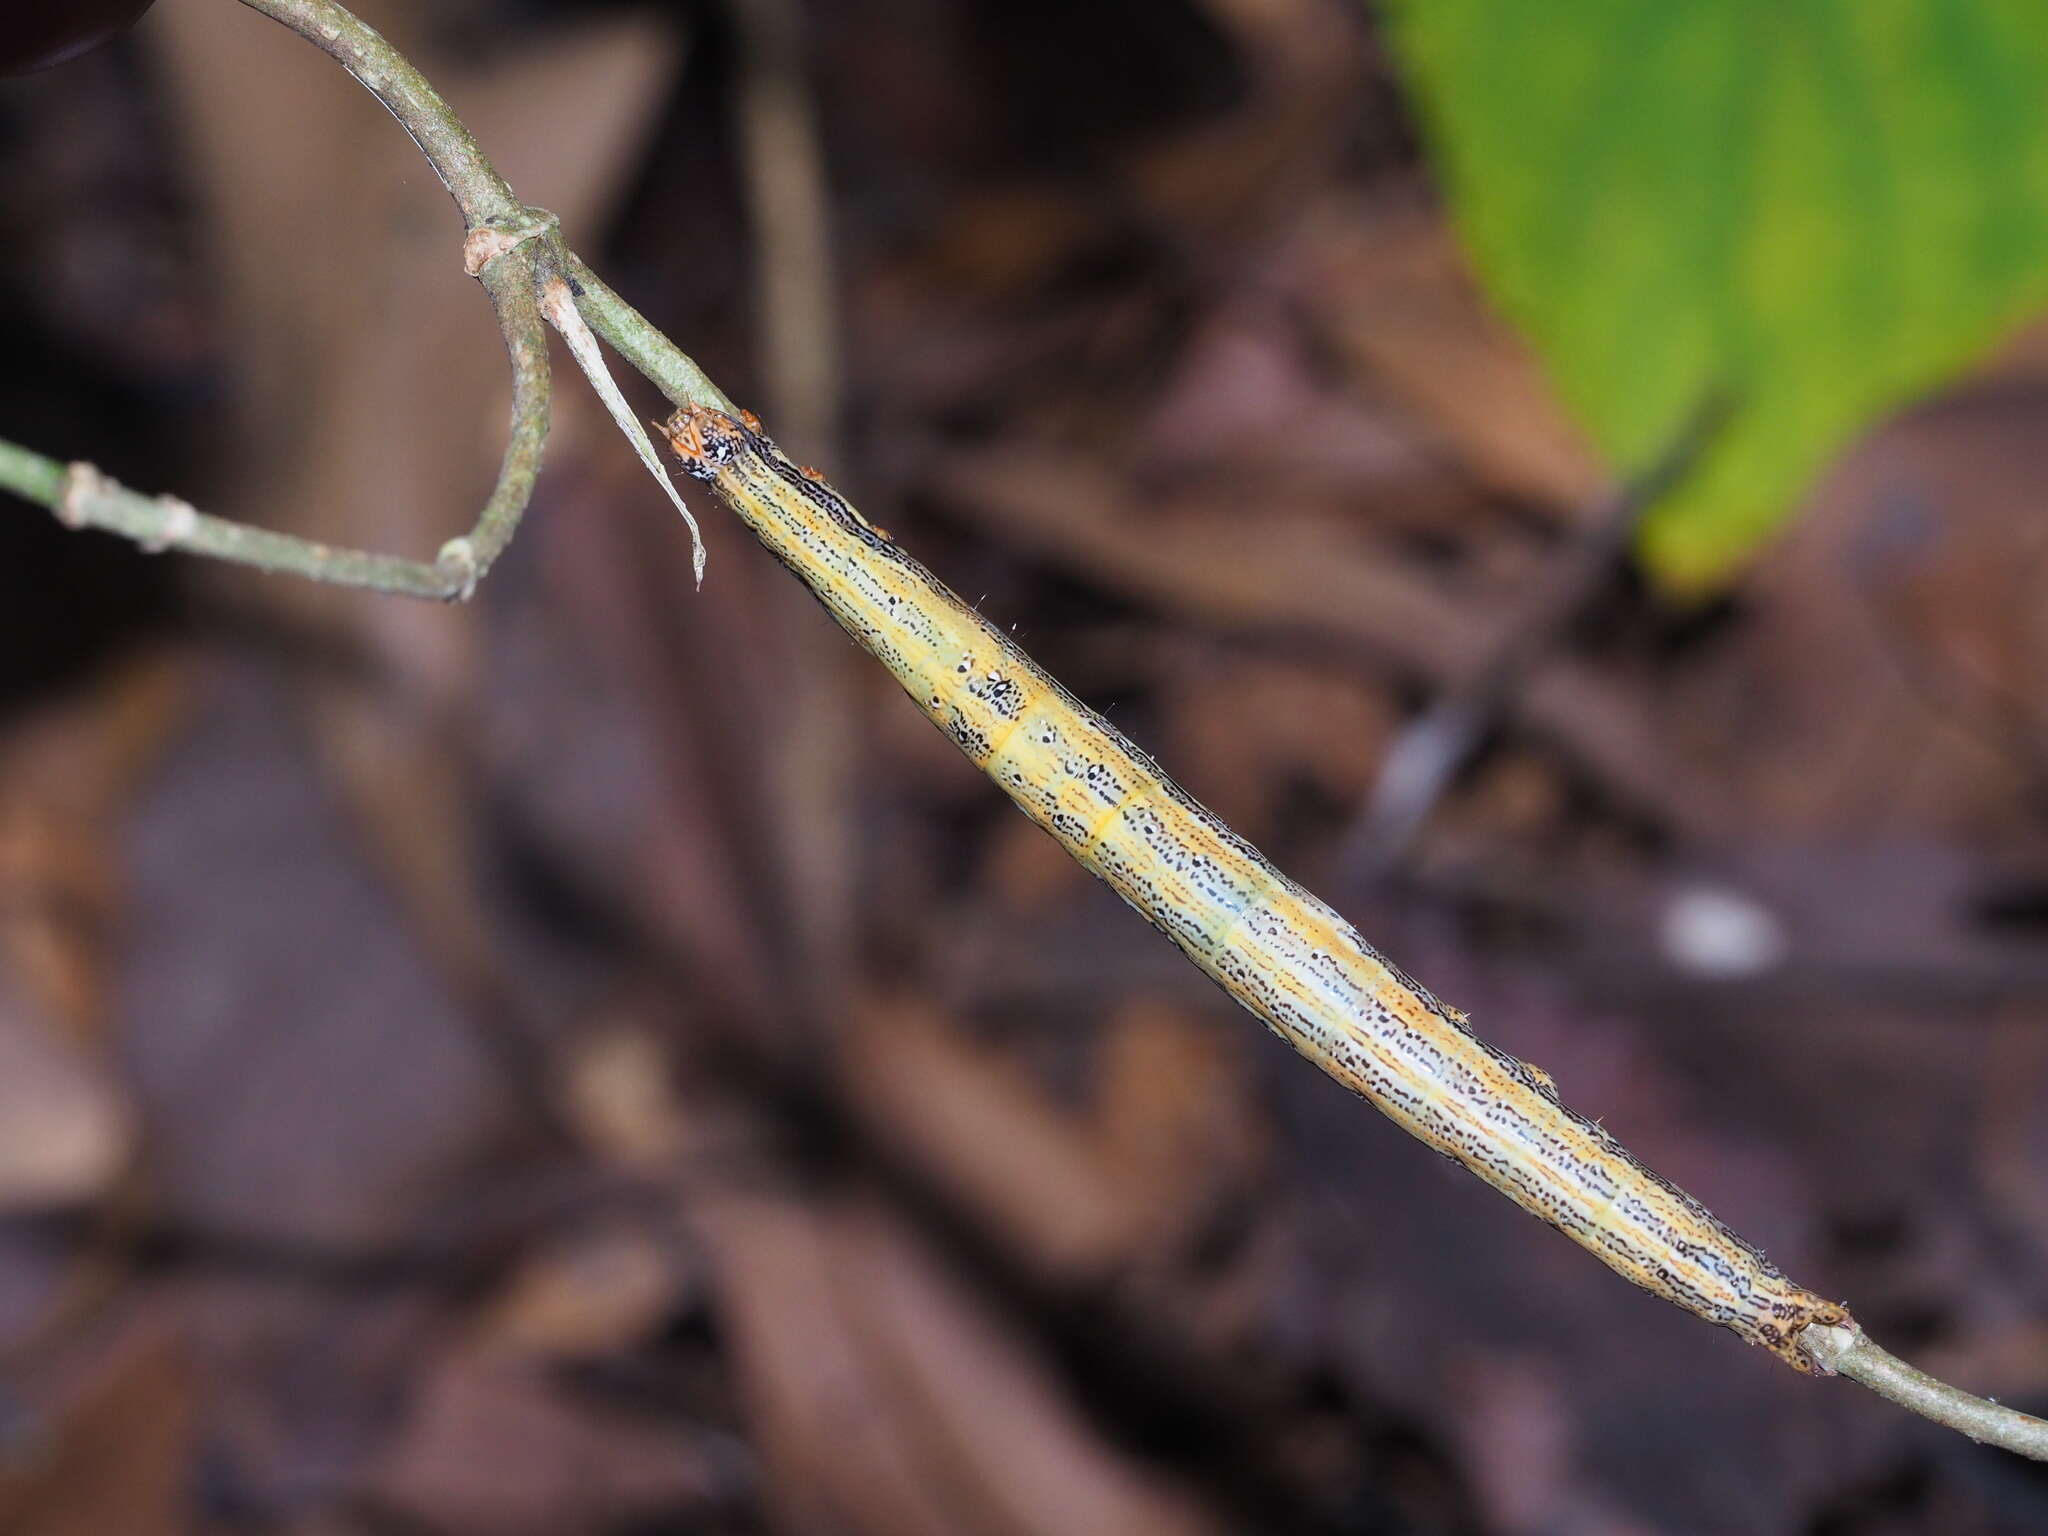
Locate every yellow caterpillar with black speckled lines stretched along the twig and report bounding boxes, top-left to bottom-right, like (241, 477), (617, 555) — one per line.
(662, 406), (1849, 1372)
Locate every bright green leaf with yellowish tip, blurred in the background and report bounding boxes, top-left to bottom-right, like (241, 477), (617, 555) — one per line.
(1391, 0), (2048, 588)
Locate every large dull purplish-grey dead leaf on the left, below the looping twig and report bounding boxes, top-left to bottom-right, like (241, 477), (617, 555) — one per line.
(115, 666), (506, 1243)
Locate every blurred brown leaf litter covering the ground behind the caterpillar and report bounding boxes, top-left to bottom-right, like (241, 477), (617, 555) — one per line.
(0, 0), (2048, 1536)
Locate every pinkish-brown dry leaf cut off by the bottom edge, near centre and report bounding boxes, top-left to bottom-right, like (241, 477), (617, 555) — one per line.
(702, 1194), (1214, 1536)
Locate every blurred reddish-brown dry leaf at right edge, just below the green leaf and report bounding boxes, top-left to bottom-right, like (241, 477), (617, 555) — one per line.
(1657, 385), (2048, 856)
